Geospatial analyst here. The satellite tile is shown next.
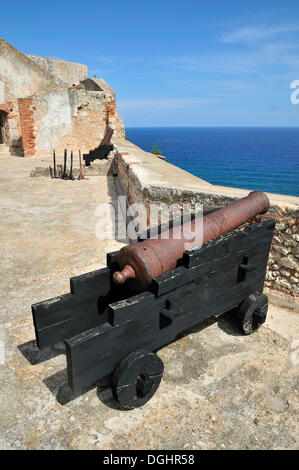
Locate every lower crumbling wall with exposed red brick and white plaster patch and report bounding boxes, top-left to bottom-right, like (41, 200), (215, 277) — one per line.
(19, 80), (124, 156)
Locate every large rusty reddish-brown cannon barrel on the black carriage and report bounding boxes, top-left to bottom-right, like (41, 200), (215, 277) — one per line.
(113, 191), (270, 292)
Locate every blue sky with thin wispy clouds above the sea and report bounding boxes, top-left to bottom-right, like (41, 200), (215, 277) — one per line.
(0, 0), (299, 127)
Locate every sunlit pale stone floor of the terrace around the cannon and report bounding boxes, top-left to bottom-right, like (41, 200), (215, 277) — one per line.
(0, 152), (299, 449)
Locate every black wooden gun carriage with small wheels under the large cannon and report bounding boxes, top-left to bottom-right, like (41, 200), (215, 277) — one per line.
(32, 216), (275, 409)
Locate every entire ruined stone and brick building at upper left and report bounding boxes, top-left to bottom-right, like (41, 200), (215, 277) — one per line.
(0, 39), (125, 157)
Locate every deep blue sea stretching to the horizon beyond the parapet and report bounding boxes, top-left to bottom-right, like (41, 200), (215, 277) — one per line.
(126, 127), (299, 196)
